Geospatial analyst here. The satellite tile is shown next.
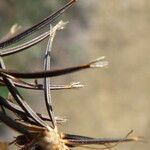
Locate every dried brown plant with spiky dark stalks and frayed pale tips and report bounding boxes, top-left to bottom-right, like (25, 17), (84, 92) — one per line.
(0, 0), (140, 150)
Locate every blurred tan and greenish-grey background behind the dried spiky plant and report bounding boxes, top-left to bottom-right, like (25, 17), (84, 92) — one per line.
(0, 0), (150, 150)
